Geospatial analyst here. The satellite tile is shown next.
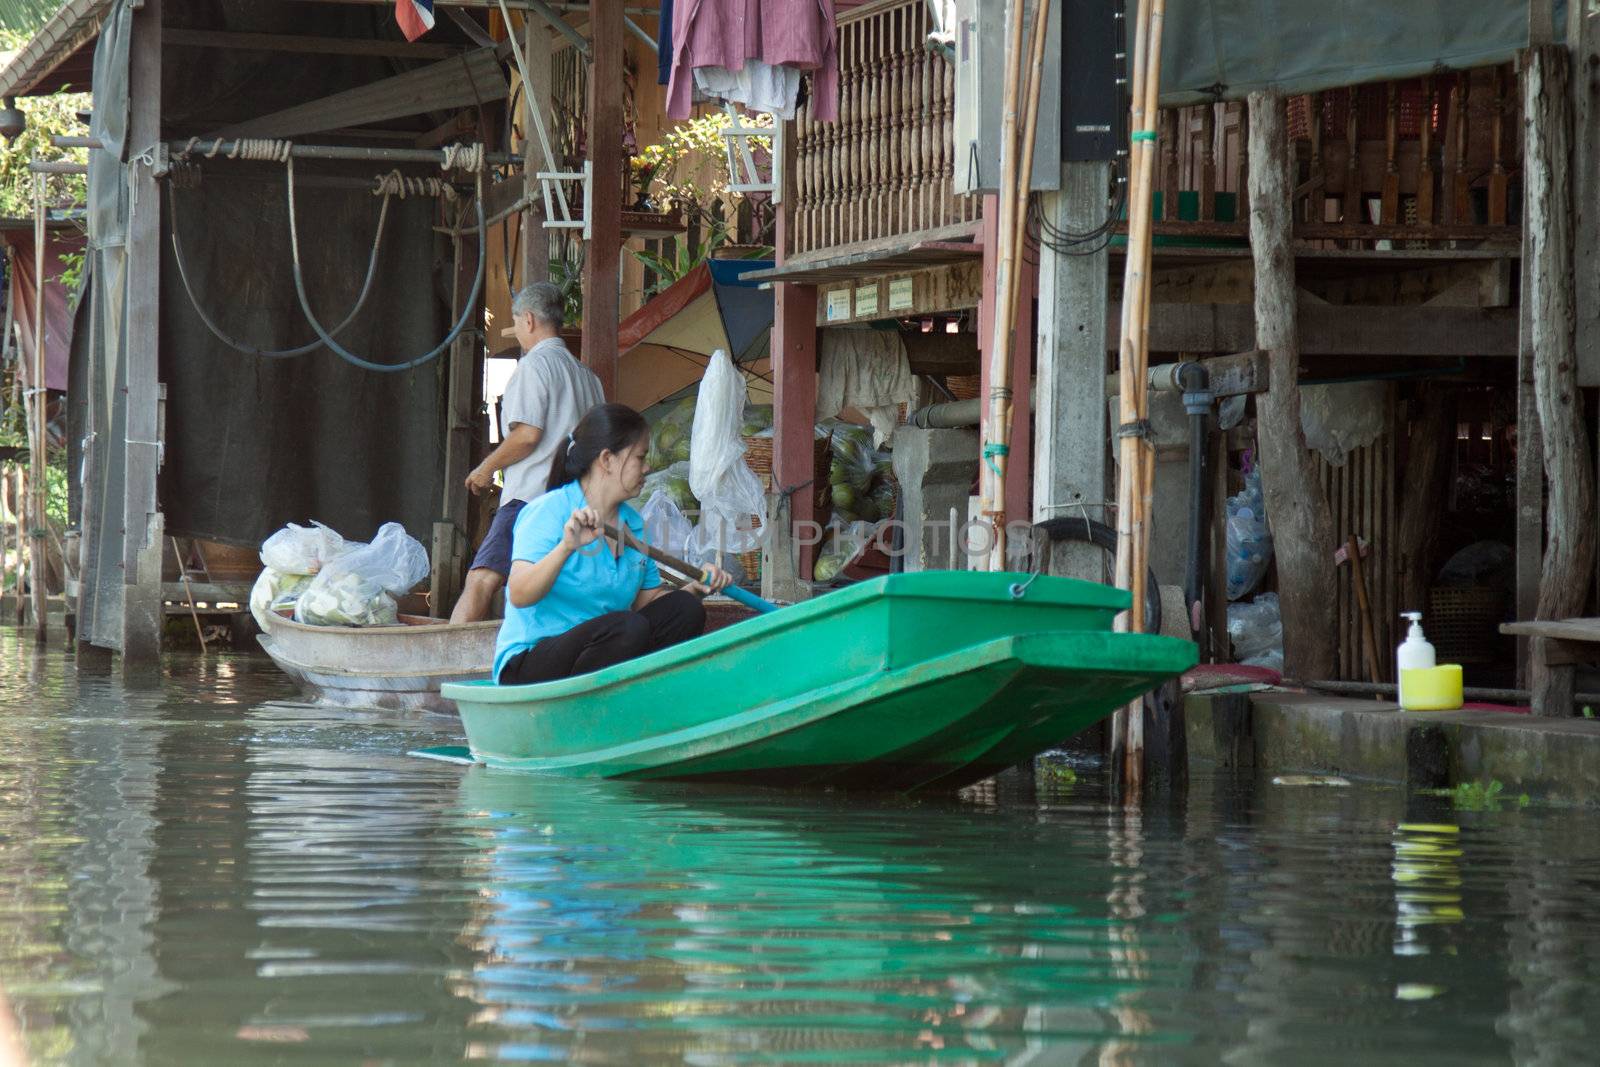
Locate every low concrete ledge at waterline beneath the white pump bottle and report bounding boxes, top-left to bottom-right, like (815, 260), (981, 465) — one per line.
(1186, 693), (1600, 806)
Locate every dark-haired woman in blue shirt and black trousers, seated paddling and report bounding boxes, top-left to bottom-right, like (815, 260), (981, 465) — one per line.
(494, 403), (730, 685)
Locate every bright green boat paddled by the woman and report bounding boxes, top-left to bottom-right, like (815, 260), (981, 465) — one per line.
(432, 571), (1197, 790)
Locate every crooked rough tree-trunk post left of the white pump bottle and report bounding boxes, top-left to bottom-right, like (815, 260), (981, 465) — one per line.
(1250, 93), (1338, 680)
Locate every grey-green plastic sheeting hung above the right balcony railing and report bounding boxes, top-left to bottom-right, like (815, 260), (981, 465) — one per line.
(1158, 0), (1566, 107)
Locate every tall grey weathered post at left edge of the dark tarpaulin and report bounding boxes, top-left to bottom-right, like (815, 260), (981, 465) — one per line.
(122, 0), (165, 678)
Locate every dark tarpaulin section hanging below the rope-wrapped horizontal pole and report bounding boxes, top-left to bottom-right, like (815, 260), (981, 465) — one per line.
(162, 165), (454, 544)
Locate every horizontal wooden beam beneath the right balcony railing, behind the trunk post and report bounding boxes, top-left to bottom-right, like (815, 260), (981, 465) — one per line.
(1106, 301), (1517, 358)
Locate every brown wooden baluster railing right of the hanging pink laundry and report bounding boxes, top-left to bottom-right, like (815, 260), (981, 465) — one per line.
(789, 0), (979, 254)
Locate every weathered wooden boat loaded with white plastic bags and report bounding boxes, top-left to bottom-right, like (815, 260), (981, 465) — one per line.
(258, 613), (499, 712)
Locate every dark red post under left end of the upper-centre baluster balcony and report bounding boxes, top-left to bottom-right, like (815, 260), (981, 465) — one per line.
(762, 116), (818, 600)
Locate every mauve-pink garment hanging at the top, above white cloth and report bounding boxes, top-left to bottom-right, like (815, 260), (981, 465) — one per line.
(667, 0), (838, 122)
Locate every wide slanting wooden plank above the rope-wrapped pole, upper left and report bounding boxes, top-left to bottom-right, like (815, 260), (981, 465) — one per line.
(219, 48), (502, 138)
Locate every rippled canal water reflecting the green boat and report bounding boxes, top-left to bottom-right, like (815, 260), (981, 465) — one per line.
(0, 630), (1600, 1065)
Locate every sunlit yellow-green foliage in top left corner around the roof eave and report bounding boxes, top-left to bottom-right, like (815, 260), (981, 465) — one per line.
(0, 29), (90, 218)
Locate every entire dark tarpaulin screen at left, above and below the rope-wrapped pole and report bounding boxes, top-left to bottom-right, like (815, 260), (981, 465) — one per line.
(141, 3), (483, 544)
